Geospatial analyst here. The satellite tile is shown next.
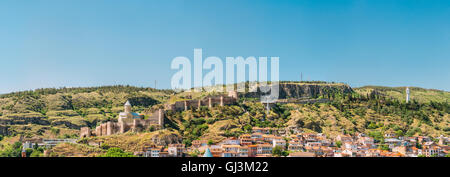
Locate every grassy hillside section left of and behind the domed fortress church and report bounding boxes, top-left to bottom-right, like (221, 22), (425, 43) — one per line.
(0, 86), (174, 138)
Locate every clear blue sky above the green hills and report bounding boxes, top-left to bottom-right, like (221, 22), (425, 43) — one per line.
(0, 0), (450, 93)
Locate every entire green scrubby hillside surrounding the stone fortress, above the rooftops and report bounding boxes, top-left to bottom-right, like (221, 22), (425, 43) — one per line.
(0, 81), (450, 156)
